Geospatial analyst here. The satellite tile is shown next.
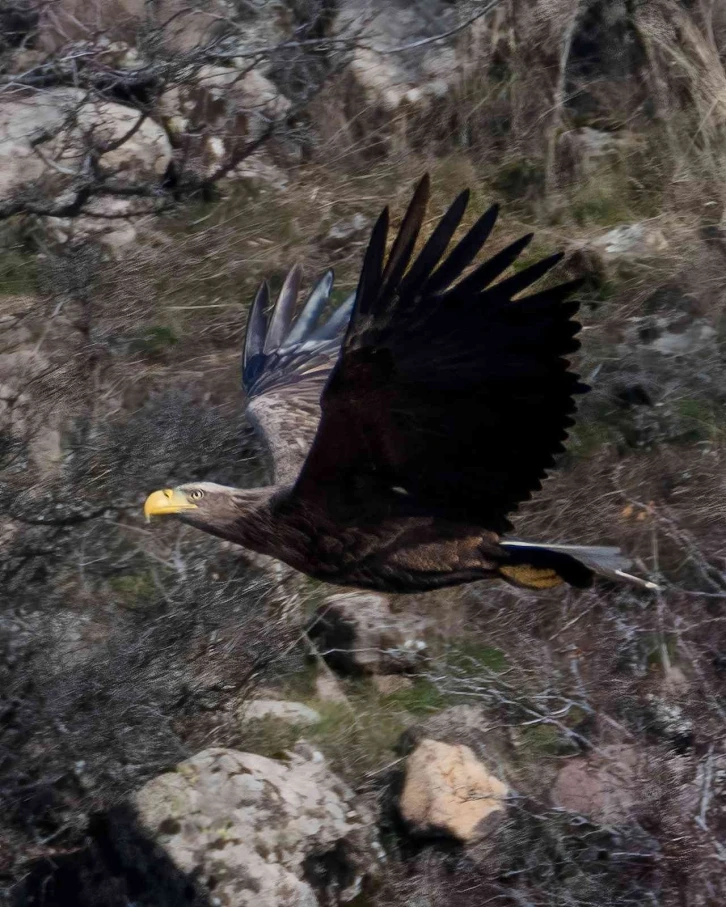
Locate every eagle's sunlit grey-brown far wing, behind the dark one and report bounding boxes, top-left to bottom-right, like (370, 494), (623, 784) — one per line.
(242, 267), (355, 484)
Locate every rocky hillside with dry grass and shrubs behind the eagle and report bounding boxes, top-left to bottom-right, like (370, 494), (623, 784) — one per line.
(0, 0), (726, 907)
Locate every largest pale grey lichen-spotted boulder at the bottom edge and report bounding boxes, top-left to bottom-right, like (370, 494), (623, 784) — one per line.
(135, 744), (380, 907)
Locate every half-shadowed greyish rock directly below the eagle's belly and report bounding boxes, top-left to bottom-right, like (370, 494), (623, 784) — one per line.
(308, 592), (426, 674)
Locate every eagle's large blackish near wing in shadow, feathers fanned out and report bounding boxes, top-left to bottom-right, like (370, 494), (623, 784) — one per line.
(294, 177), (587, 532)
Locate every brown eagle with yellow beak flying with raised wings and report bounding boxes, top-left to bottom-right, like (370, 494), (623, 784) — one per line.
(144, 175), (654, 593)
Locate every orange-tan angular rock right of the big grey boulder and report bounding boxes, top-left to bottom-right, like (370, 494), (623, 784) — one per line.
(399, 740), (510, 843)
